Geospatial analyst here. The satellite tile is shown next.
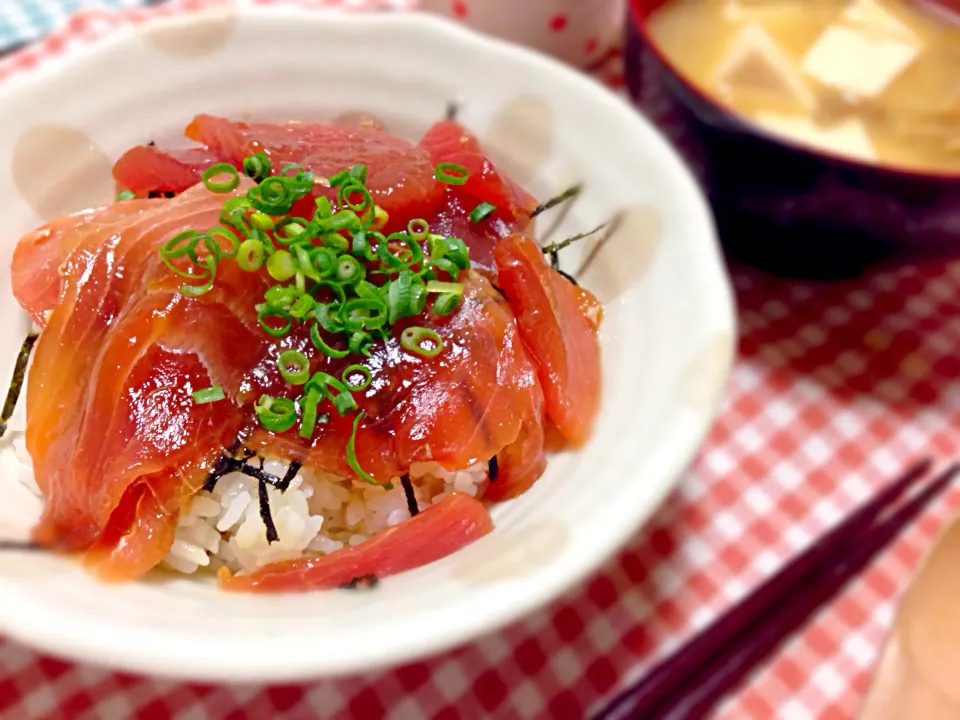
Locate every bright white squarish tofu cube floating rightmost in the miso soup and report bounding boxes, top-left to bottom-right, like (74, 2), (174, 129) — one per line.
(803, 25), (920, 99)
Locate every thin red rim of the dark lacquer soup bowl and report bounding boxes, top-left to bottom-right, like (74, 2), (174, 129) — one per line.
(626, 0), (960, 184)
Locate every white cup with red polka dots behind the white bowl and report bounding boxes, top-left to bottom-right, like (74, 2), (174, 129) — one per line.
(419, 0), (625, 66)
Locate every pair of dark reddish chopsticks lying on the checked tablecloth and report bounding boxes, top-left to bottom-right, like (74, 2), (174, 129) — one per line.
(596, 460), (957, 719)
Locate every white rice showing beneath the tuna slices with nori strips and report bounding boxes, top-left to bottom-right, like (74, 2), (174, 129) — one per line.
(162, 460), (488, 574)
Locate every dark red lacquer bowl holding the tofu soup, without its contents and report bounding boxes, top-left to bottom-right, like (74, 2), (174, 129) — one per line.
(625, 0), (960, 279)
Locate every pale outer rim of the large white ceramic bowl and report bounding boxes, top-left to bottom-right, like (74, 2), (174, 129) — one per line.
(0, 5), (737, 683)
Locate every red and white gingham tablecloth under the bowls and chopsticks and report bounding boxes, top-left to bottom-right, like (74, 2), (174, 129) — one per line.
(0, 3), (960, 720)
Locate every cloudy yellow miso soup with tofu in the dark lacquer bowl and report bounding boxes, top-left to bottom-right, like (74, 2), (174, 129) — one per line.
(647, 0), (960, 173)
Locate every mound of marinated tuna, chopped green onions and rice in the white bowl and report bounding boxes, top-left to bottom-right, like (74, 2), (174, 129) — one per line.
(11, 115), (602, 591)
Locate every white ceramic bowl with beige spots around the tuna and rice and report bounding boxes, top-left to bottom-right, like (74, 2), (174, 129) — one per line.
(0, 8), (735, 681)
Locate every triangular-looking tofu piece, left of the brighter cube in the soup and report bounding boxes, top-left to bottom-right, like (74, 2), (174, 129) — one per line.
(714, 25), (814, 110)
